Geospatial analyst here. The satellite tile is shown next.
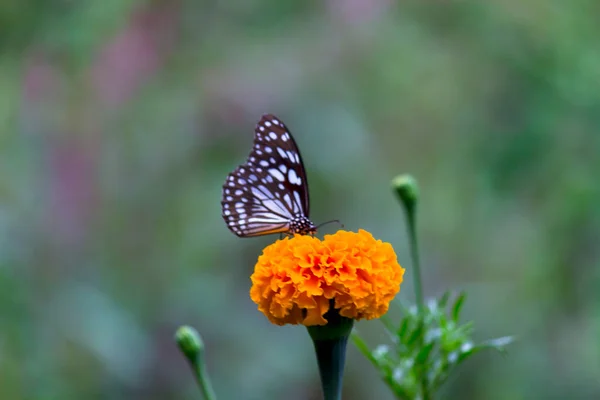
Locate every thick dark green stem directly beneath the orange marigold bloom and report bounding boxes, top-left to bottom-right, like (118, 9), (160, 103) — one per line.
(307, 309), (354, 400)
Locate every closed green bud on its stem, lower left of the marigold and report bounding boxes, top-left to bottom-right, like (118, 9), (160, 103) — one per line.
(175, 326), (217, 400)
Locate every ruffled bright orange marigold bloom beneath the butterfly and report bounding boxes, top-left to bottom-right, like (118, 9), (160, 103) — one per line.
(250, 229), (404, 326)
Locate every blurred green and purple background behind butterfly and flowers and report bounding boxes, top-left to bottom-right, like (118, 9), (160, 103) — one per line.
(0, 0), (600, 400)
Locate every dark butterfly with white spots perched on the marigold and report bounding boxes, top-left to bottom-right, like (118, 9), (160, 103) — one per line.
(221, 114), (317, 237)
